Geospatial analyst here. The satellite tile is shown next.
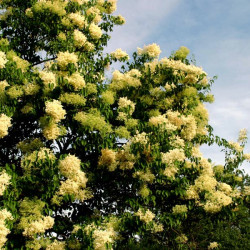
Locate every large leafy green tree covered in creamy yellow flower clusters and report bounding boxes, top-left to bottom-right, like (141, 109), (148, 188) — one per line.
(0, 0), (250, 249)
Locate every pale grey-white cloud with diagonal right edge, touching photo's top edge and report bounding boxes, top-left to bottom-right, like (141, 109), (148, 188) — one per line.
(107, 0), (181, 52)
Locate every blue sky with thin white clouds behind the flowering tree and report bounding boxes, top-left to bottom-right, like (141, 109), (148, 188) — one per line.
(107, 0), (250, 174)
